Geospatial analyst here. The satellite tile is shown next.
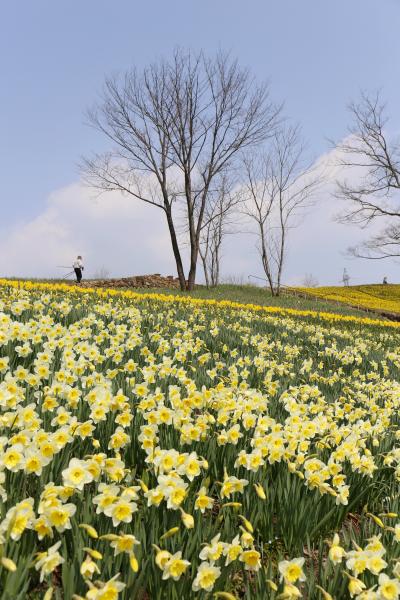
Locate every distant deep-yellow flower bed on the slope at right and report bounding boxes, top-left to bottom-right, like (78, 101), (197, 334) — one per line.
(296, 285), (400, 314)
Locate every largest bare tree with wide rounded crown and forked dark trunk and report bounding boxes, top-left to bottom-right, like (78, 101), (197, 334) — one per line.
(83, 50), (280, 290)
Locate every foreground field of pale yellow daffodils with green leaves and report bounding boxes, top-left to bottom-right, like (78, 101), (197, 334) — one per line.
(0, 280), (400, 600)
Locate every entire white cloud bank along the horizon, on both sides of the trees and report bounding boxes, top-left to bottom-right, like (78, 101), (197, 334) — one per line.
(0, 144), (399, 285)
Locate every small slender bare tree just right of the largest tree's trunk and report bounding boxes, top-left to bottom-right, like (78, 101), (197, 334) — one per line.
(199, 173), (243, 287)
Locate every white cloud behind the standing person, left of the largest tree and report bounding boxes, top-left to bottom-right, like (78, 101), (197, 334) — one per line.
(0, 184), (174, 277)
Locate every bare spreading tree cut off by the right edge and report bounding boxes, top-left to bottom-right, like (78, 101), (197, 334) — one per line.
(336, 93), (400, 259)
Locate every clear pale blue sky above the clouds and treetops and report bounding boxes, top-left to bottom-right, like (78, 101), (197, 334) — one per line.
(0, 0), (400, 284)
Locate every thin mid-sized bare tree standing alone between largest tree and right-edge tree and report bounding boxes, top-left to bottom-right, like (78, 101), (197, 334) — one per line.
(245, 126), (322, 296)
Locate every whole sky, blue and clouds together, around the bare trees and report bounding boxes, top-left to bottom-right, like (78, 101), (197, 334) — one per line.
(0, 0), (400, 285)
